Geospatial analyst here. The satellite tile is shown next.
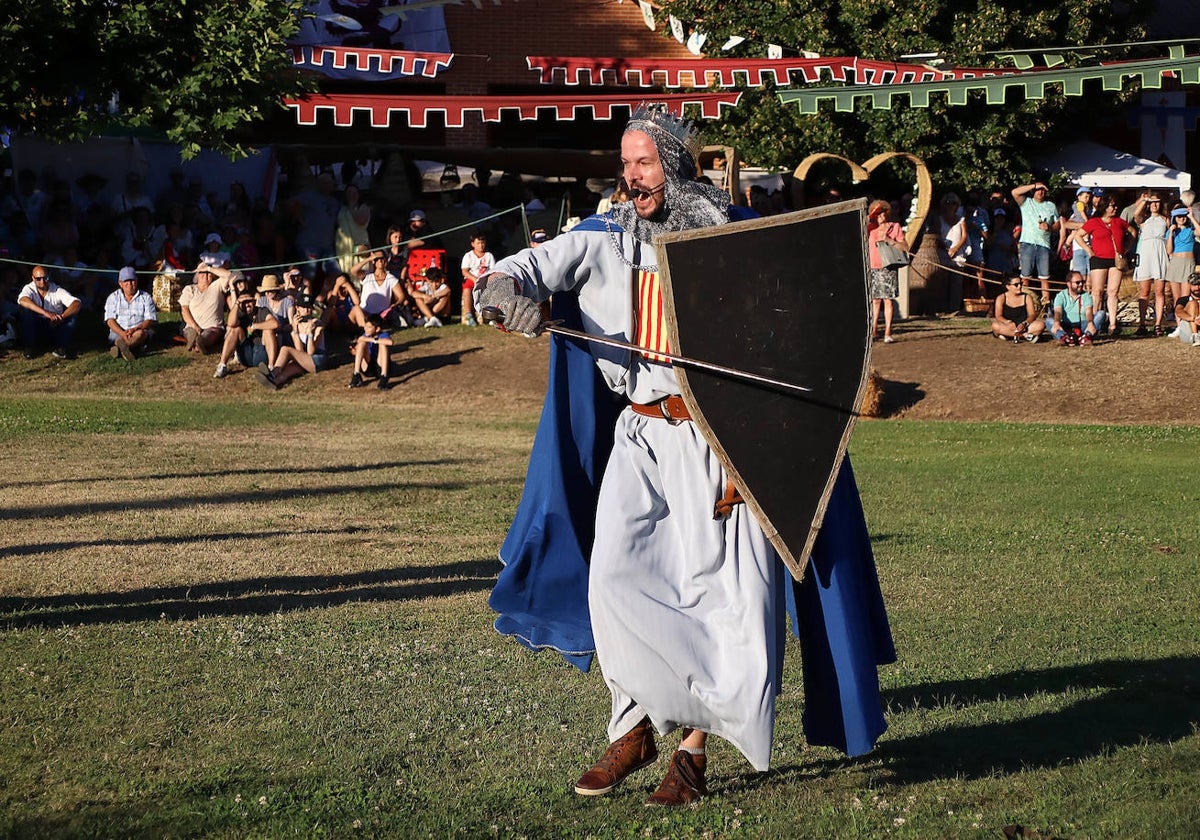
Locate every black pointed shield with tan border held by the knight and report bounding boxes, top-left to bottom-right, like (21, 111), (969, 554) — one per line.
(655, 199), (871, 580)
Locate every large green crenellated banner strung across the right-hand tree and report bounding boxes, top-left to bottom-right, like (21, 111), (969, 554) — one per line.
(779, 58), (1200, 114)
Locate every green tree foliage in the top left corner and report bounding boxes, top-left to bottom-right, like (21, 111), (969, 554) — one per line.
(0, 0), (313, 156)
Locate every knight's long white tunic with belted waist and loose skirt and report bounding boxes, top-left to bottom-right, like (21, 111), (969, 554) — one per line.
(496, 214), (784, 770)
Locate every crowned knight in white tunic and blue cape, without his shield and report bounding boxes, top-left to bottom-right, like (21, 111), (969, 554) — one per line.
(476, 106), (895, 805)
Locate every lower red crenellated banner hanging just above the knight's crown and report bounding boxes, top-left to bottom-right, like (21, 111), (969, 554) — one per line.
(283, 91), (742, 128)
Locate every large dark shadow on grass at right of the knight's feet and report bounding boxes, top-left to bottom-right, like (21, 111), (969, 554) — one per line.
(748, 656), (1200, 788)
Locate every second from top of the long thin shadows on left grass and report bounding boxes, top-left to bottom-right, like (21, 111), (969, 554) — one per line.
(0, 481), (482, 520)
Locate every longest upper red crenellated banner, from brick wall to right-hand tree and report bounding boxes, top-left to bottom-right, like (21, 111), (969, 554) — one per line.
(526, 55), (1021, 89)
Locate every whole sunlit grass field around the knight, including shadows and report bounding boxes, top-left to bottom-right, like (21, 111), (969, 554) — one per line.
(0, 388), (1200, 838)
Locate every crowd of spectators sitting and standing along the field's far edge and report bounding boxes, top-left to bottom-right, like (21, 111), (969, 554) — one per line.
(0, 159), (1200, 376)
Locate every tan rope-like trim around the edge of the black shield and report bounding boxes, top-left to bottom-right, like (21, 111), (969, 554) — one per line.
(654, 199), (871, 581)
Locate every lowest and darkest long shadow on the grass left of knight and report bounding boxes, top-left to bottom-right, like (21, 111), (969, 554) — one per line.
(0, 556), (499, 629)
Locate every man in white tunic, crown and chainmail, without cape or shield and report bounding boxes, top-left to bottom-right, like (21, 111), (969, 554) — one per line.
(478, 107), (786, 804)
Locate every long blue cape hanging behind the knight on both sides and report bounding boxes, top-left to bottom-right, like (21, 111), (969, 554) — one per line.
(488, 212), (895, 756)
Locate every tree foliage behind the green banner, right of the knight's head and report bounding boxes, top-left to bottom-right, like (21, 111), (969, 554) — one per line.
(666, 0), (1154, 186)
